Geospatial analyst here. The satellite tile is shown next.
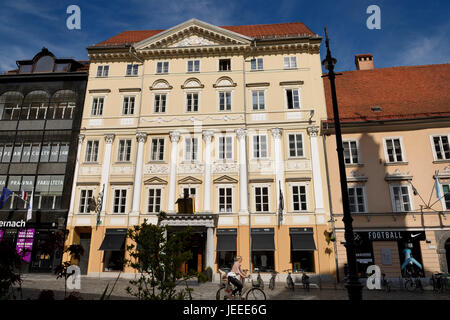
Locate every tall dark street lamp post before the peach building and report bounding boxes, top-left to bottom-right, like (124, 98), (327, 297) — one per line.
(322, 27), (362, 300)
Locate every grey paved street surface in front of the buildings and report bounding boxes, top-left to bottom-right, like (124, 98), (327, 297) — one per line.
(12, 274), (450, 300)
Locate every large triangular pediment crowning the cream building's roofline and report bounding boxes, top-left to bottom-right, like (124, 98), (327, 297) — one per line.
(135, 19), (252, 50)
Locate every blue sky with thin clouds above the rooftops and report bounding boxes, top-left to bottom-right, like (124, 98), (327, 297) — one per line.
(0, 0), (450, 72)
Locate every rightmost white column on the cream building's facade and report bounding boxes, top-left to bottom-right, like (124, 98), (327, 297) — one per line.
(308, 126), (325, 213)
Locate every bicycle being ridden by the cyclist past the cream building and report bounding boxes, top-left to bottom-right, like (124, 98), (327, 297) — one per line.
(216, 269), (266, 300)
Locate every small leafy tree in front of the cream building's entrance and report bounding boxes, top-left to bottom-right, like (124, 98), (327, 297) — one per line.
(126, 212), (197, 300)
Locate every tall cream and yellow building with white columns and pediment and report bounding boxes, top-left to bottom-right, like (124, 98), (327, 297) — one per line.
(67, 19), (336, 278)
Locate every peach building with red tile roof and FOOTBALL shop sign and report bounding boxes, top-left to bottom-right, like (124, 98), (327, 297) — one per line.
(322, 54), (450, 278)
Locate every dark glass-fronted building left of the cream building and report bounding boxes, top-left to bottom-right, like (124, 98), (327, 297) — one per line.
(0, 48), (88, 272)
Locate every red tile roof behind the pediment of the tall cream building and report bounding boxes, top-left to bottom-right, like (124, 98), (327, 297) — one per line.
(96, 22), (315, 46)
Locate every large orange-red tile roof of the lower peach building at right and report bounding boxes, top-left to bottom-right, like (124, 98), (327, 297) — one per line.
(323, 64), (450, 122)
